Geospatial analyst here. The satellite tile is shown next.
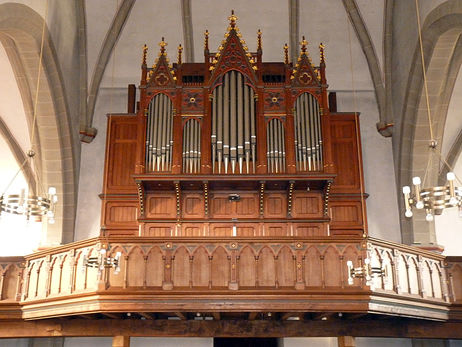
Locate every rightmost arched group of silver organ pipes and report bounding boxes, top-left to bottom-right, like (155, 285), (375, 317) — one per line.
(294, 93), (323, 171)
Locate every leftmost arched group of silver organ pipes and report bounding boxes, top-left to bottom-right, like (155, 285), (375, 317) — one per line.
(146, 94), (173, 172)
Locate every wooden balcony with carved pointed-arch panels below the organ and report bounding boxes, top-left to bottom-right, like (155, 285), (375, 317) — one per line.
(0, 237), (462, 321)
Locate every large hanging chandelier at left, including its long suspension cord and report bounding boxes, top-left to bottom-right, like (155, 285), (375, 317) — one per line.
(0, 1), (58, 224)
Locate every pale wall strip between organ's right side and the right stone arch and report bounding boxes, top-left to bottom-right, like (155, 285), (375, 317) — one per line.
(337, 90), (401, 242)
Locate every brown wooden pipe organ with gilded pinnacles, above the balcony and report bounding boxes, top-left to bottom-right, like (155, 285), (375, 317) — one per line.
(102, 15), (366, 242)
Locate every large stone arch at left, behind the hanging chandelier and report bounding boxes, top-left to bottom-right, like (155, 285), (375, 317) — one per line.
(0, 3), (77, 244)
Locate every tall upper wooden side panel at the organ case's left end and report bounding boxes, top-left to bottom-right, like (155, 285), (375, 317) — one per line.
(104, 116), (138, 193)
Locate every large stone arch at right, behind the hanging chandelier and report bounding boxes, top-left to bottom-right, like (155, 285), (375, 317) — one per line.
(397, 0), (462, 244)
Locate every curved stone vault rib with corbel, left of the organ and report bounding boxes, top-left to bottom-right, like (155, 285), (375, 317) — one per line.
(85, 0), (136, 142)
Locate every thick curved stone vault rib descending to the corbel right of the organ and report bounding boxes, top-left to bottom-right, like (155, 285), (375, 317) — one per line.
(342, 0), (385, 136)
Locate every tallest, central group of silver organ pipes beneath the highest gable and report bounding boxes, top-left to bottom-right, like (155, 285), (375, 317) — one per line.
(211, 70), (257, 174)
